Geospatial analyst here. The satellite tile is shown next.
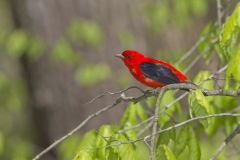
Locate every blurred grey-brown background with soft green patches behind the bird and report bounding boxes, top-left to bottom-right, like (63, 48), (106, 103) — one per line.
(0, 0), (237, 160)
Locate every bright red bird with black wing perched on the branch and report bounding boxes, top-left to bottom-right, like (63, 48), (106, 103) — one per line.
(116, 50), (190, 88)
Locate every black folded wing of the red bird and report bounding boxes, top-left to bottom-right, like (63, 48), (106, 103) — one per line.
(140, 62), (180, 84)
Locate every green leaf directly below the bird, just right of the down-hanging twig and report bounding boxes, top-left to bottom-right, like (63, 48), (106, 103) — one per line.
(158, 91), (180, 127)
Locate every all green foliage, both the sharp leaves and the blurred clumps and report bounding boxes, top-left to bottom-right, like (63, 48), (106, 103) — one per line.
(0, 0), (240, 160)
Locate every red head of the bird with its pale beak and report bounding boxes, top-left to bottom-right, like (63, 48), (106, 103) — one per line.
(116, 50), (144, 64)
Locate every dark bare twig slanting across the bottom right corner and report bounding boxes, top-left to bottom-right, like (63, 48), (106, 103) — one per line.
(210, 124), (240, 160)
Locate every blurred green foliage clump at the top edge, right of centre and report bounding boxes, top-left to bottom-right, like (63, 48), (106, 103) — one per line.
(145, 0), (208, 34)
